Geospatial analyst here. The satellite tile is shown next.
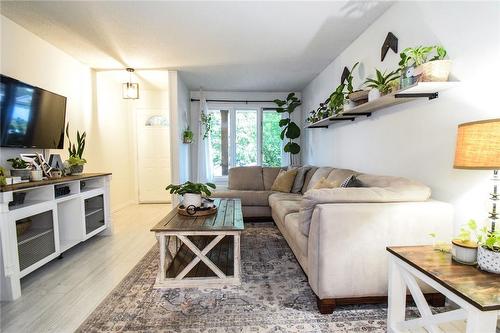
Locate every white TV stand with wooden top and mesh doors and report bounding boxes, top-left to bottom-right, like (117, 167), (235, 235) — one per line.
(0, 173), (112, 301)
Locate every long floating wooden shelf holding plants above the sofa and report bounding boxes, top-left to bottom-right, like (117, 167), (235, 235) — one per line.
(306, 82), (458, 128)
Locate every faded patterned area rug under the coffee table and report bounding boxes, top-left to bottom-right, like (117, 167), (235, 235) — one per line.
(78, 223), (415, 333)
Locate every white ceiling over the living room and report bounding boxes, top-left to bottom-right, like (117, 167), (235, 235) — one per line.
(0, 1), (392, 91)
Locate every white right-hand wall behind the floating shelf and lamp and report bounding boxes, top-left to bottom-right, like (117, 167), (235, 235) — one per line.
(302, 1), (500, 231)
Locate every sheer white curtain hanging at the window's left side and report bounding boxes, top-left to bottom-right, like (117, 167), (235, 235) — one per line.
(197, 93), (213, 183)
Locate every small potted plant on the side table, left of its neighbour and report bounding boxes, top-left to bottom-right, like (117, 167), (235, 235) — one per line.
(451, 220), (482, 265)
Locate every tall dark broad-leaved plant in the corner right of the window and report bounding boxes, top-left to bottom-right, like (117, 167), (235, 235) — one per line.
(274, 93), (302, 161)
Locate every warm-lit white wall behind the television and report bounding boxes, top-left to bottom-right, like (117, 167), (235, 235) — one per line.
(0, 16), (136, 209)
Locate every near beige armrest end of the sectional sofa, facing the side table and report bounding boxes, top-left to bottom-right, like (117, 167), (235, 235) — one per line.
(307, 201), (453, 299)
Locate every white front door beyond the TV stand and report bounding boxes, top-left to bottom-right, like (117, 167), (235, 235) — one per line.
(137, 109), (171, 203)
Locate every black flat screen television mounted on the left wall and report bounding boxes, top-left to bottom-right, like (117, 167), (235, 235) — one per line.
(0, 75), (66, 149)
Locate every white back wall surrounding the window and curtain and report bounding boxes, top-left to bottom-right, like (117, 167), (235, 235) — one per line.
(190, 91), (304, 180)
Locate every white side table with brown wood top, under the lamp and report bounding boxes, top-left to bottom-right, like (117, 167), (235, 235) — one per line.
(387, 246), (500, 333)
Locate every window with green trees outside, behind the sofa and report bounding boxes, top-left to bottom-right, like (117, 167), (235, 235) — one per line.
(209, 107), (281, 178)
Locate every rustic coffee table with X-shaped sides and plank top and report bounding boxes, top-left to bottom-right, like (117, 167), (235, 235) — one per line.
(151, 199), (244, 288)
